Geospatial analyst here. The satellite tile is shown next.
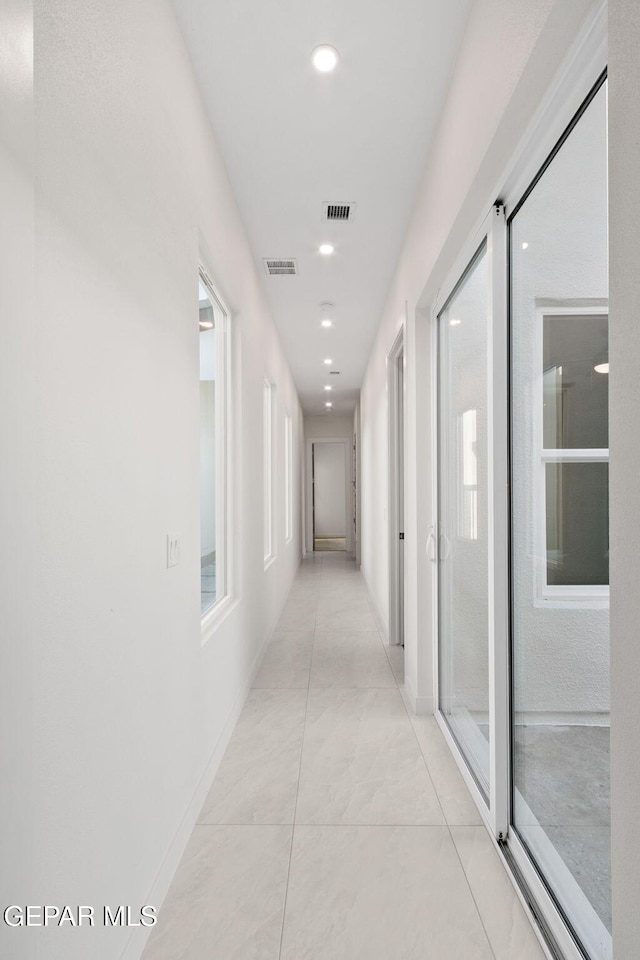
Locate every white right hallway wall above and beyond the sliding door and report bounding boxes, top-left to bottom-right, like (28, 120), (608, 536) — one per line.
(361, 0), (593, 711)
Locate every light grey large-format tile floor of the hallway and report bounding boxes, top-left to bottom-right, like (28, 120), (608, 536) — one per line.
(144, 553), (544, 960)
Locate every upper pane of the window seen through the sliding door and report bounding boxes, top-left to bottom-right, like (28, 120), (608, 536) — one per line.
(543, 313), (609, 450)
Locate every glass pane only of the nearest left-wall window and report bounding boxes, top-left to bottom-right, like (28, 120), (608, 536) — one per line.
(199, 284), (216, 613)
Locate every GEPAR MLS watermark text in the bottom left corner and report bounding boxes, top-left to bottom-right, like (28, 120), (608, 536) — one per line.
(3, 903), (158, 927)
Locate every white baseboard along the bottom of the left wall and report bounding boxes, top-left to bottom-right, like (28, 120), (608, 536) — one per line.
(120, 569), (297, 960)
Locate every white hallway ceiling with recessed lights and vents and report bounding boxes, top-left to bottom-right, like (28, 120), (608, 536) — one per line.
(173, 0), (472, 414)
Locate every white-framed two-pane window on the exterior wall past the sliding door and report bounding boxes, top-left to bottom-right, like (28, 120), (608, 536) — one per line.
(535, 304), (609, 602)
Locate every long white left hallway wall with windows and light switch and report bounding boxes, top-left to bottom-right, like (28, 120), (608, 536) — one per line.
(0, 0), (303, 960)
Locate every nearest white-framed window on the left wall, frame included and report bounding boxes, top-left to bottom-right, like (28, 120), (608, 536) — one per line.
(198, 267), (230, 629)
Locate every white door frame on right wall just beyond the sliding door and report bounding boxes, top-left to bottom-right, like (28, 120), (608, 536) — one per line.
(387, 326), (406, 646)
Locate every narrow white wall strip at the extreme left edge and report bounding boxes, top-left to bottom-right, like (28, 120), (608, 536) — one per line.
(0, 0), (35, 928)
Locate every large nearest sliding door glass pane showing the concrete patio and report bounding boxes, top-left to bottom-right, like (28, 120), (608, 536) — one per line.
(510, 79), (611, 960)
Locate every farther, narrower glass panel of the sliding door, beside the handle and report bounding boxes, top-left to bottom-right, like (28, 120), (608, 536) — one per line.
(438, 242), (490, 802)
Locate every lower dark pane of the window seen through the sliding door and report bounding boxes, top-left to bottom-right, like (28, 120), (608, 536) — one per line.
(545, 463), (609, 586)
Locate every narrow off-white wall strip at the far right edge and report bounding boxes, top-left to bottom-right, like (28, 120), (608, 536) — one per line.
(609, 0), (640, 960)
